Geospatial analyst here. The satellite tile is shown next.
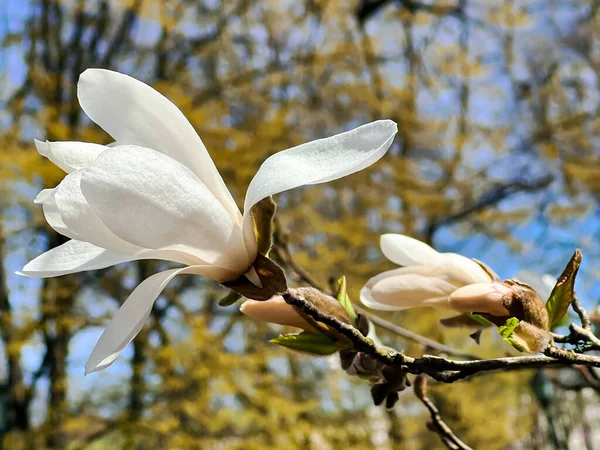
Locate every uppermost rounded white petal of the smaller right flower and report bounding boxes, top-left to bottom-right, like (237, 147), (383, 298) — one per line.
(379, 234), (441, 266)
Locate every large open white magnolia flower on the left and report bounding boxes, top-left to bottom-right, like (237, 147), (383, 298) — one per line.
(21, 69), (397, 373)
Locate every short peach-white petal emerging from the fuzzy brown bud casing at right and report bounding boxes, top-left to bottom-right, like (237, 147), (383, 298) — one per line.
(449, 283), (512, 316)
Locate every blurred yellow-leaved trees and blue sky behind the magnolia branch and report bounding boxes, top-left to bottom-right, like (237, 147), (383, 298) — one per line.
(0, 0), (600, 450)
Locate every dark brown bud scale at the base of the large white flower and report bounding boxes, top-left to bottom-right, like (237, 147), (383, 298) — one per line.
(221, 253), (287, 300)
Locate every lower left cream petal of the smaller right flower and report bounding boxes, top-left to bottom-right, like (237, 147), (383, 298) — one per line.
(361, 269), (456, 311)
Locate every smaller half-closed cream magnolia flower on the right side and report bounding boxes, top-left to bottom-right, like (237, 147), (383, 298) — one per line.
(360, 234), (498, 314)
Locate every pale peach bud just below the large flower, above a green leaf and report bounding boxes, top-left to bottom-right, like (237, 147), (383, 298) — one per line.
(240, 295), (317, 333)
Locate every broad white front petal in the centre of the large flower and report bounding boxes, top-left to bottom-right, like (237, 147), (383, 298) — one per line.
(81, 145), (252, 273)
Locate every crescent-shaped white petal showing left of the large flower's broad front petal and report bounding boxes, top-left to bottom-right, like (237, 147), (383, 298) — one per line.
(54, 169), (143, 255)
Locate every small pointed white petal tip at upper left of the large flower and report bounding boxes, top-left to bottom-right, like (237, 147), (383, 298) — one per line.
(35, 139), (106, 173)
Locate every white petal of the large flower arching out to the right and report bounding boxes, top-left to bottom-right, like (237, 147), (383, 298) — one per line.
(244, 120), (398, 253)
